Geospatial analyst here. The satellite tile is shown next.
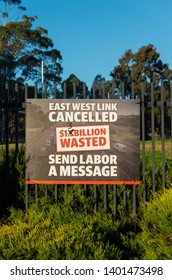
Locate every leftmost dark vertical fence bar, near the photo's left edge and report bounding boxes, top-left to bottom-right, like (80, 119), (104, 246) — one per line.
(5, 82), (9, 209)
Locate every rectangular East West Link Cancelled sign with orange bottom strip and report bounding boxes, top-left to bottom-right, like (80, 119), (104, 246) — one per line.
(26, 99), (140, 184)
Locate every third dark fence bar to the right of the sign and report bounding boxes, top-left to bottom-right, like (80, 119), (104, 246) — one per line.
(161, 83), (165, 188)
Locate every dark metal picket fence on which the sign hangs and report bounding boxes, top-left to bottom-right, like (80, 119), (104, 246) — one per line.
(0, 82), (172, 218)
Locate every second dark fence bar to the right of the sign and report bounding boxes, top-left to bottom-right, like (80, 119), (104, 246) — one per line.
(151, 83), (155, 193)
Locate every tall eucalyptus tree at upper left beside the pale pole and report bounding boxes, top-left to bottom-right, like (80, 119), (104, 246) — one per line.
(0, 0), (62, 88)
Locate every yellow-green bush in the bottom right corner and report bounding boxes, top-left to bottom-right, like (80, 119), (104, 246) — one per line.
(122, 189), (172, 260)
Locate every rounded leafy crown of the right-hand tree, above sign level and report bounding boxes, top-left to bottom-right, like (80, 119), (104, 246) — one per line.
(110, 44), (172, 99)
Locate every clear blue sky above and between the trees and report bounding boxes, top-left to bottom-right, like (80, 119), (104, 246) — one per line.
(22, 0), (172, 87)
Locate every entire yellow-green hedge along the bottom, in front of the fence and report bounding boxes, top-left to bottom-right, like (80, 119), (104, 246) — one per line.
(0, 189), (172, 260)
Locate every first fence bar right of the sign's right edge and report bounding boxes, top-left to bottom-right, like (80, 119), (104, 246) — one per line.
(141, 83), (146, 201)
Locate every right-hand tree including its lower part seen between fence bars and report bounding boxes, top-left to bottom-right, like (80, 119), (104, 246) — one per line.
(110, 44), (172, 139)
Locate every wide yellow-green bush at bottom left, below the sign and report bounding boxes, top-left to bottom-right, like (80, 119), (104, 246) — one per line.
(0, 200), (122, 260)
